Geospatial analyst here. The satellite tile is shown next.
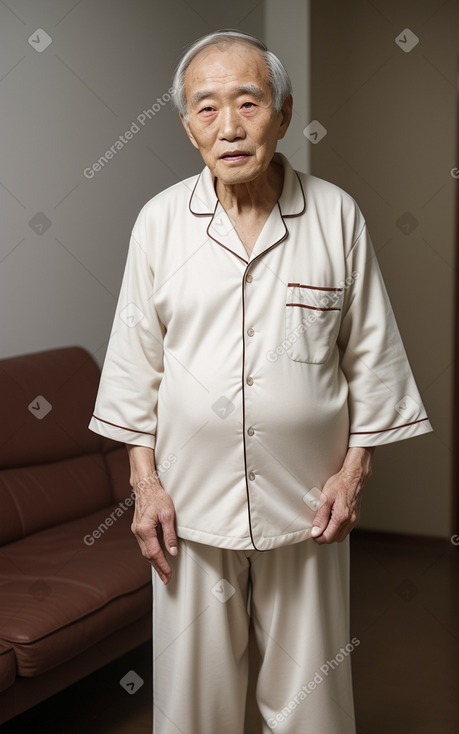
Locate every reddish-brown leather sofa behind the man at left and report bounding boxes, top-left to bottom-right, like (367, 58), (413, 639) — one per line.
(0, 347), (151, 723)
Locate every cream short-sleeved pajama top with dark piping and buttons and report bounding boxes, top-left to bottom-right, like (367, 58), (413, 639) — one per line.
(90, 153), (432, 550)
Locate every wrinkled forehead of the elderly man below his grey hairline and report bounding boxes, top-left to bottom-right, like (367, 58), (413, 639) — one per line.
(185, 40), (269, 93)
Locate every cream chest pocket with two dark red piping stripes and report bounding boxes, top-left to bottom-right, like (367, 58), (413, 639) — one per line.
(285, 283), (344, 364)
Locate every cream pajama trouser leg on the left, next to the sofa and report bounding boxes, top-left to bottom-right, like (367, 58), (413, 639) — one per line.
(152, 539), (249, 734)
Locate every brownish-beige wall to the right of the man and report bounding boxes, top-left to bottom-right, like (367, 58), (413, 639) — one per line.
(310, 0), (459, 536)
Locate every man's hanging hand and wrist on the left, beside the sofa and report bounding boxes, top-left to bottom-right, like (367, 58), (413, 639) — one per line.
(128, 445), (178, 584)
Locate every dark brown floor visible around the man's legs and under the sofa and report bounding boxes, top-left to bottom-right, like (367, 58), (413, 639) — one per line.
(0, 531), (459, 734)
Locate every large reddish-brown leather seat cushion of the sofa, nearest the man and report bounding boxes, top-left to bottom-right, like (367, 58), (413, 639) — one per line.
(0, 501), (151, 676)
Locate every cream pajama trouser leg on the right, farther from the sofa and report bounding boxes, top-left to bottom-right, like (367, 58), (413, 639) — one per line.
(251, 538), (359, 734)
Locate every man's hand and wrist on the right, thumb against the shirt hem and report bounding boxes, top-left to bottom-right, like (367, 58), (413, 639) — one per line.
(311, 446), (374, 543)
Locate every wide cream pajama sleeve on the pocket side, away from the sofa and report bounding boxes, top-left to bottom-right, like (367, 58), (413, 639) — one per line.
(338, 215), (432, 446)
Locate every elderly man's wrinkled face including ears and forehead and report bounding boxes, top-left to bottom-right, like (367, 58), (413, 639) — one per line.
(180, 42), (292, 185)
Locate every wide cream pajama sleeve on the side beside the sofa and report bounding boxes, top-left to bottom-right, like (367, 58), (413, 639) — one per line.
(89, 207), (165, 448)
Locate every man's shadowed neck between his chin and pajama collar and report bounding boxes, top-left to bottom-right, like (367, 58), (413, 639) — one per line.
(216, 161), (284, 214)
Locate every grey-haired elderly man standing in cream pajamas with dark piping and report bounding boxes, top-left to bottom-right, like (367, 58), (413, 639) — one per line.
(90, 31), (431, 734)
